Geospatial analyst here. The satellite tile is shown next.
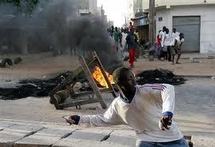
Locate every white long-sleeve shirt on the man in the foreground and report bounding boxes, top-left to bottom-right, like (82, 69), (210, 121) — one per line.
(79, 84), (183, 142)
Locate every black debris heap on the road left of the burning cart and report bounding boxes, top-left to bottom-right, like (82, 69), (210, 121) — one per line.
(0, 71), (84, 100)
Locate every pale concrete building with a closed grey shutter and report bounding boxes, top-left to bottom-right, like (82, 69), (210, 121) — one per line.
(143, 0), (215, 53)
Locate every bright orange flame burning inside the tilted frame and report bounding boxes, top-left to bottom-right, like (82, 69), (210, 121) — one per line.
(93, 66), (114, 88)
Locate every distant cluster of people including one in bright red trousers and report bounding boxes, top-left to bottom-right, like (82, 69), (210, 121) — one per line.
(108, 23), (139, 68)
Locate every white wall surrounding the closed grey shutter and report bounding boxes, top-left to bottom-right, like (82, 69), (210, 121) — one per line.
(156, 5), (215, 53)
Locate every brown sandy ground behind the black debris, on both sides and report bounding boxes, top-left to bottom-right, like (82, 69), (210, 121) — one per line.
(0, 53), (215, 80)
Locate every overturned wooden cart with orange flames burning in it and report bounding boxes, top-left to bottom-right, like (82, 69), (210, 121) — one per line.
(49, 52), (116, 109)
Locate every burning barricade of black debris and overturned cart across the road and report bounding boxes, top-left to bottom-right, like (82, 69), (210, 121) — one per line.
(0, 52), (185, 109)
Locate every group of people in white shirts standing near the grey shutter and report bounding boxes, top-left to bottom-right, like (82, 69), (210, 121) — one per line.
(156, 26), (184, 64)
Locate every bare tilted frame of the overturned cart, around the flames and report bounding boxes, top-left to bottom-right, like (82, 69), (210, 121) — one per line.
(50, 51), (116, 109)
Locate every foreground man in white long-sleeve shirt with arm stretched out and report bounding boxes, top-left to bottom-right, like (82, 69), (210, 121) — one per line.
(66, 67), (188, 147)
